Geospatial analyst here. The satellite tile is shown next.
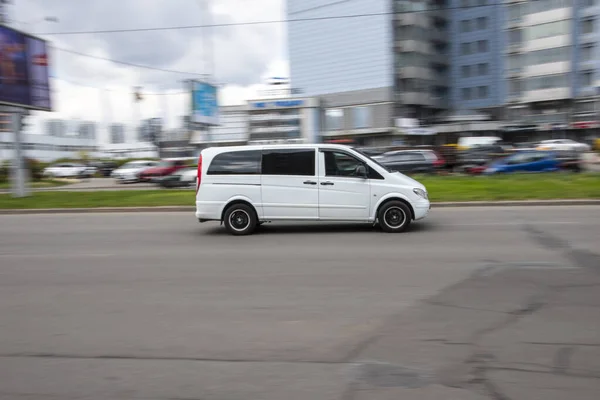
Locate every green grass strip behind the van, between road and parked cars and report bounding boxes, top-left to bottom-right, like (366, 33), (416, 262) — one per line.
(0, 173), (600, 209)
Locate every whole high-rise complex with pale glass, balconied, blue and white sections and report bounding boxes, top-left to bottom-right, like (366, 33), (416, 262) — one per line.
(287, 0), (600, 144)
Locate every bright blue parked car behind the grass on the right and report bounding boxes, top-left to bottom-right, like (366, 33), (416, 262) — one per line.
(484, 151), (561, 174)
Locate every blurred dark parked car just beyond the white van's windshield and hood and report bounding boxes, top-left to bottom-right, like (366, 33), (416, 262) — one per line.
(372, 150), (445, 173)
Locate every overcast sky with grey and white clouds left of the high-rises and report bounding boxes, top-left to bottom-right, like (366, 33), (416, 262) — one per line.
(9, 0), (288, 141)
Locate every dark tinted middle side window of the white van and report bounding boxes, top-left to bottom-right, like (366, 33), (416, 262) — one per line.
(262, 149), (315, 176)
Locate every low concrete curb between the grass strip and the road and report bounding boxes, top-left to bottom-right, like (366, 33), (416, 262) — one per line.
(0, 199), (600, 215)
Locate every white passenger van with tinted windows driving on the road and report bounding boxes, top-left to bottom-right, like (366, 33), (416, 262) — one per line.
(196, 144), (430, 235)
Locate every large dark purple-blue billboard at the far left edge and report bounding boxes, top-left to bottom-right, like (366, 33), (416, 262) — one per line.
(0, 25), (52, 111)
